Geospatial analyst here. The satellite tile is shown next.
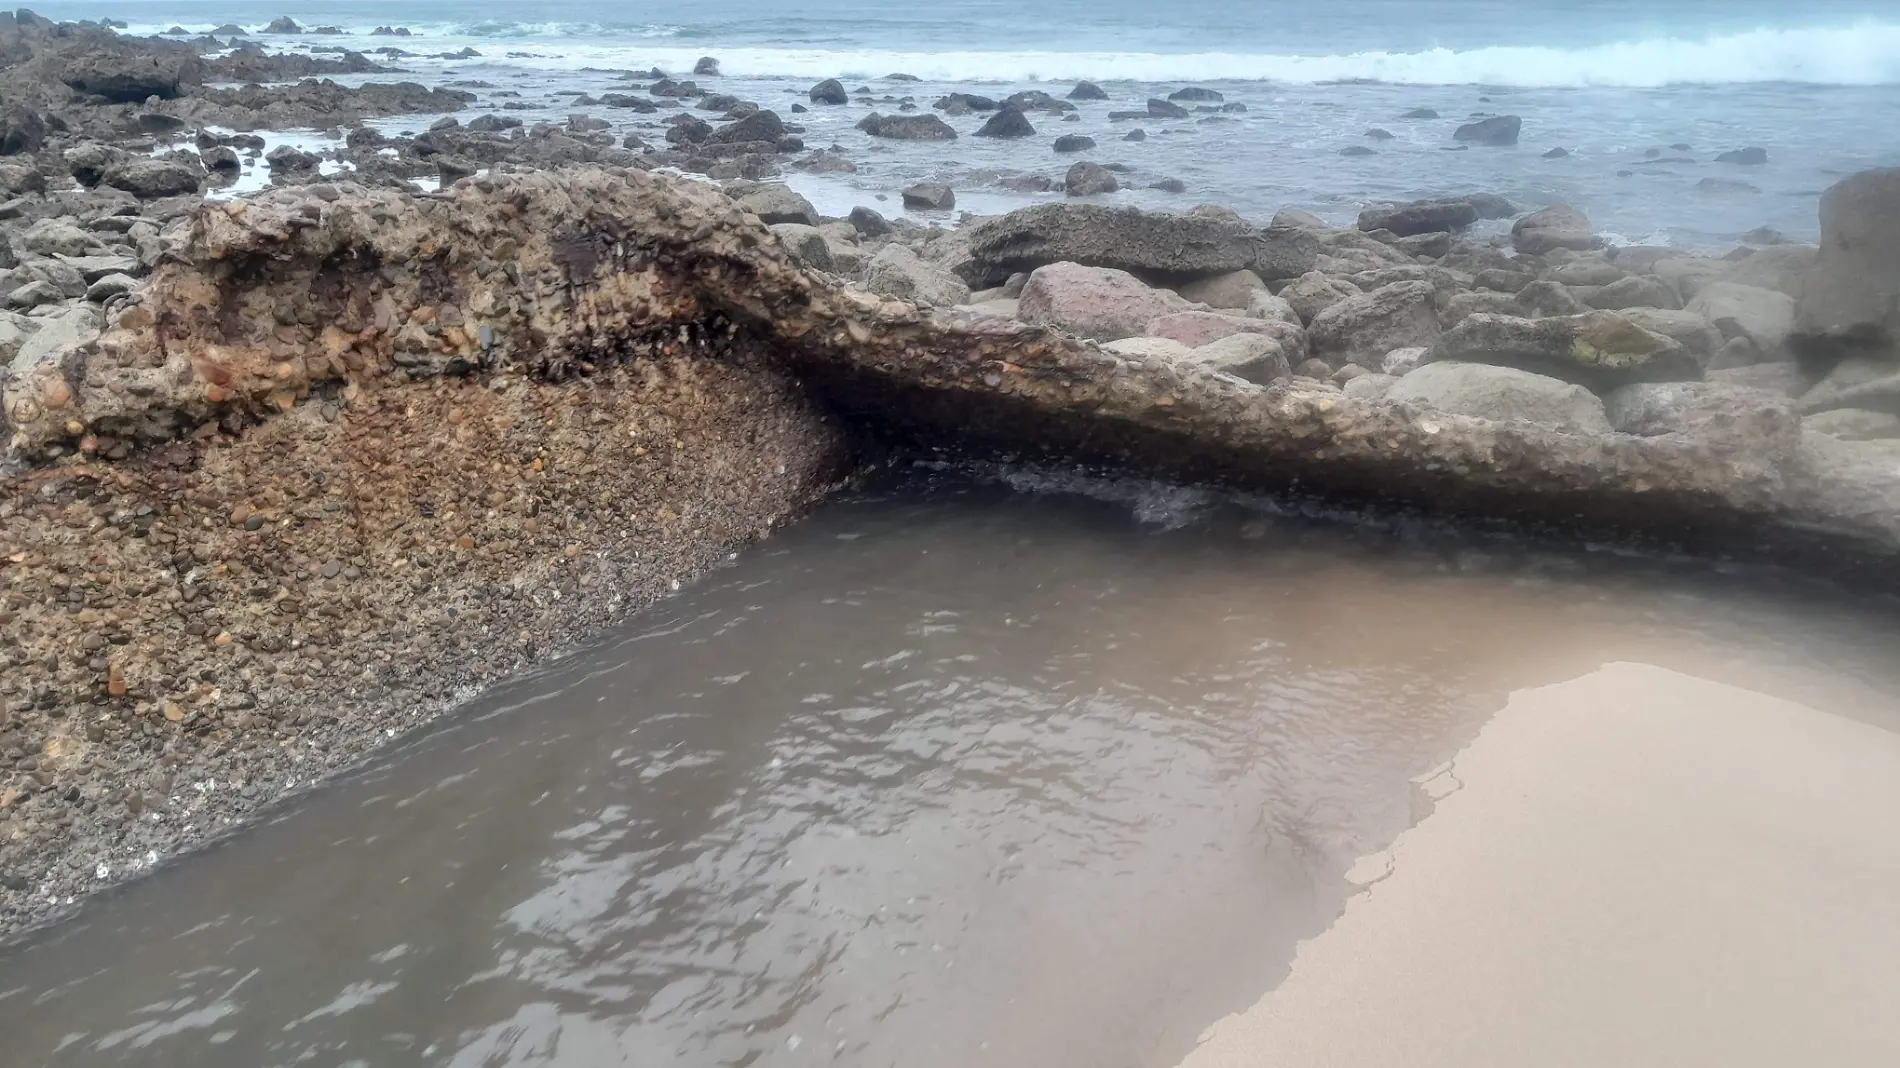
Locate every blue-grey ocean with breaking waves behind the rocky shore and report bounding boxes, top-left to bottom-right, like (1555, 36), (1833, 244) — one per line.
(38, 0), (1900, 249)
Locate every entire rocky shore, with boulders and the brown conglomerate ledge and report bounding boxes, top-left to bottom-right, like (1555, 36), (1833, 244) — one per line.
(0, 15), (1900, 935)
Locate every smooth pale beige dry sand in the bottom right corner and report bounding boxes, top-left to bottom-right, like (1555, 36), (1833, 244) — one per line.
(1182, 663), (1900, 1068)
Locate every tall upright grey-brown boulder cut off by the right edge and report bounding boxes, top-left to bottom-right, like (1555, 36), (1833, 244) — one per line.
(1793, 167), (1900, 352)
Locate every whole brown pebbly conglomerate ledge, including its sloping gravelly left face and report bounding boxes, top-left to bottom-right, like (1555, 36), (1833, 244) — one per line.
(0, 167), (1900, 931)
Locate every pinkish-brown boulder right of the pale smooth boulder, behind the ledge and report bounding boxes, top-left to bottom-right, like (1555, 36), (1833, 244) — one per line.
(1604, 382), (1801, 452)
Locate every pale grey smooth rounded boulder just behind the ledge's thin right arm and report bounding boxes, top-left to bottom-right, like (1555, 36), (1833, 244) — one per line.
(1385, 363), (1611, 433)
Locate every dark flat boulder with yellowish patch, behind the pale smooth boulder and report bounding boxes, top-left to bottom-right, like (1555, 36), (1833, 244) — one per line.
(1427, 312), (1702, 390)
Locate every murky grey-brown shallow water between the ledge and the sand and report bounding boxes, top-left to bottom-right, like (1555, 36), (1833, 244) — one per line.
(0, 477), (1900, 1068)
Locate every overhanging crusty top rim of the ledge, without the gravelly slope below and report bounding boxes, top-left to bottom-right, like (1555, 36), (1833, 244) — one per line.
(4, 167), (1900, 553)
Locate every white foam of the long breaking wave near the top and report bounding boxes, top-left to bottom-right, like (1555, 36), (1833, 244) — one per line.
(118, 21), (1900, 87)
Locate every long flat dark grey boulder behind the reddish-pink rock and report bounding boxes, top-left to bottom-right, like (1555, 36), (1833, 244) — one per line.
(969, 203), (1319, 287)
